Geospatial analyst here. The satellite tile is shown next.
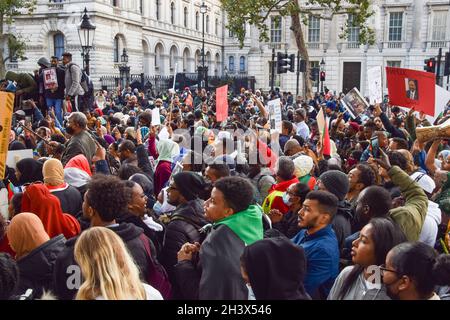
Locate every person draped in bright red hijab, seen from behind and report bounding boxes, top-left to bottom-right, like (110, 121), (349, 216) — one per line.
(22, 184), (80, 239)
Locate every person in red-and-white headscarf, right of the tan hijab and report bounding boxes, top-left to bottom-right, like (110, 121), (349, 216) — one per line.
(64, 154), (92, 197)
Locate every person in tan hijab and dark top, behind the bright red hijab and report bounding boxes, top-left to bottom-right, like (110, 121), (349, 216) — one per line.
(42, 159), (83, 217)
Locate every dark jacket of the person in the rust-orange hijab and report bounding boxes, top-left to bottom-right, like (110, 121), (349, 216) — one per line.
(16, 234), (66, 298)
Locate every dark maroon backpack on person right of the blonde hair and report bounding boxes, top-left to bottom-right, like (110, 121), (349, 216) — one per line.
(139, 233), (172, 300)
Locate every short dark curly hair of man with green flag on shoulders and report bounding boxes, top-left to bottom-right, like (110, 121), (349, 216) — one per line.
(214, 176), (254, 213)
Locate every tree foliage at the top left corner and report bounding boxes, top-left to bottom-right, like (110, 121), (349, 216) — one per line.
(0, 0), (36, 78)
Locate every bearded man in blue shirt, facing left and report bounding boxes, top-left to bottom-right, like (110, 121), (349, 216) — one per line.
(292, 191), (339, 299)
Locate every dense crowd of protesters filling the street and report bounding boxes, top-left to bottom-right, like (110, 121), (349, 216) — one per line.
(0, 53), (450, 300)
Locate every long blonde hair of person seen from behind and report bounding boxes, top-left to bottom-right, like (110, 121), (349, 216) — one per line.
(74, 227), (146, 300)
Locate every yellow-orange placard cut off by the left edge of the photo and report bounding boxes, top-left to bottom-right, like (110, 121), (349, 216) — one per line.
(0, 92), (14, 180)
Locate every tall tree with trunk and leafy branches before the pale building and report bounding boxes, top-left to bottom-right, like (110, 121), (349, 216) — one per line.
(221, 0), (375, 98)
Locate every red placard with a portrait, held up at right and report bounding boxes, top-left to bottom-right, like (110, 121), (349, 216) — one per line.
(386, 67), (436, 116)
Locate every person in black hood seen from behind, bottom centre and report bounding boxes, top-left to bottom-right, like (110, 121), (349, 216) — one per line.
(241, 237), (311, 300)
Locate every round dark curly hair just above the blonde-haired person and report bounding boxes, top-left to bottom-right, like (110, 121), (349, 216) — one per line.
(86, 174), (130, 221)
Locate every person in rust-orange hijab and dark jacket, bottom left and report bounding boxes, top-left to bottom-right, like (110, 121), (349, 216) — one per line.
(7, 212), (66, 297)
